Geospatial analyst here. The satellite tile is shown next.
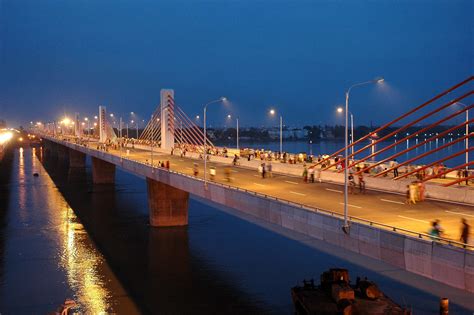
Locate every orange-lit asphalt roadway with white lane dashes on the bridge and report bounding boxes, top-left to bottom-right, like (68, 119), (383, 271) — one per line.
(90, 143), (474, 244)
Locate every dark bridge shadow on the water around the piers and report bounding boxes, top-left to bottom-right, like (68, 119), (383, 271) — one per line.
(42, 152), (270, 314)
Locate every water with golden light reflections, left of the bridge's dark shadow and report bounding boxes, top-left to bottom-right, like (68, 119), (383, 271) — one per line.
(0, 148), (139, 314)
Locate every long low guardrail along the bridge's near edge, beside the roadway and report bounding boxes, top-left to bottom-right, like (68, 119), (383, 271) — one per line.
(40, 136), (474, 250)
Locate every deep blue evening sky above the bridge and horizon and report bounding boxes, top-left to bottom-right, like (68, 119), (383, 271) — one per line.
(0, 0), (474, 125)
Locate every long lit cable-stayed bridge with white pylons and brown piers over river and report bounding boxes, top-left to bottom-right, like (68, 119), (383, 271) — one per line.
(31, 78), (474, 292)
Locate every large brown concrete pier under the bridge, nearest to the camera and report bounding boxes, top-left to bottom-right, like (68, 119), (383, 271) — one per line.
(146, 178), (189, 227)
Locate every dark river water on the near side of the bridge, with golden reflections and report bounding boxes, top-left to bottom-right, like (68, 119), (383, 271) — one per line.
(0, 148), (474, 314)
